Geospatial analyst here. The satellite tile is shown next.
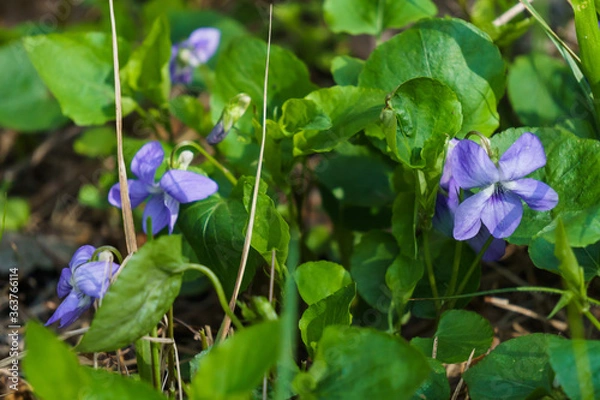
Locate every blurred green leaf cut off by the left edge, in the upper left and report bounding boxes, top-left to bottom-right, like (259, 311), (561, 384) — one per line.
(0, 42), (66, 132)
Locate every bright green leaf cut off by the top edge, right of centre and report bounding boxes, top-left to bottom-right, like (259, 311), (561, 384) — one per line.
(323, 0), (437, 36)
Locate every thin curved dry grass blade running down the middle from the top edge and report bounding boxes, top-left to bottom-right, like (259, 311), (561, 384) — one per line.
(219, 4), (273, 340)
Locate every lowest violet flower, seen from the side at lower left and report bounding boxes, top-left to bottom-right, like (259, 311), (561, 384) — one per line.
(46, 245), (119, 328)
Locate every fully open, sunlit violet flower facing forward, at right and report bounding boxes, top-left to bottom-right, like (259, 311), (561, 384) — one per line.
(451, 132), (558, 240)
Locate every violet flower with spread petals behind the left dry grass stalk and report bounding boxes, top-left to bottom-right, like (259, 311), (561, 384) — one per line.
(108, 141), (218, 234)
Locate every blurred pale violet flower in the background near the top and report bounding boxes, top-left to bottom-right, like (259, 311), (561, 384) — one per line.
(169, 28), (221, 85)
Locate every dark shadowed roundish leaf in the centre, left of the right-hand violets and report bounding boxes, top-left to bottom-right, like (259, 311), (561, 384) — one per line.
(315, 143), (394, 208)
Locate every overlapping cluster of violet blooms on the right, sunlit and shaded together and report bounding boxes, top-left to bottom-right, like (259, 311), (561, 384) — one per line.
(434, 132), (558, 261)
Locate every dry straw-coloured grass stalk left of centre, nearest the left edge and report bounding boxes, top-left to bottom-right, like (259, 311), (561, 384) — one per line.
(108, 0), (137, 254)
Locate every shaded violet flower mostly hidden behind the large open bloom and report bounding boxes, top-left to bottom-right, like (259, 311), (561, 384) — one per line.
(433, 139), (506, 261)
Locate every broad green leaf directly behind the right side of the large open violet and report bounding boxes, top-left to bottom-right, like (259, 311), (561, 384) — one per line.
(492, 128), (600, 245)
